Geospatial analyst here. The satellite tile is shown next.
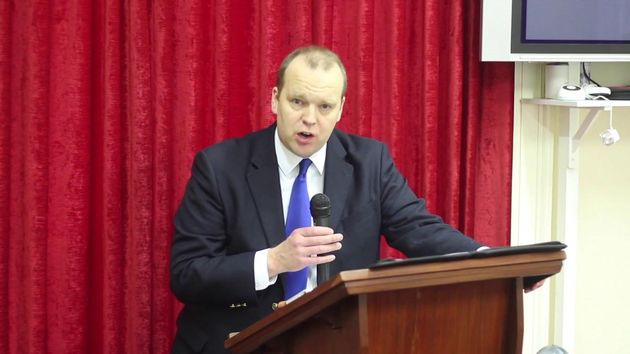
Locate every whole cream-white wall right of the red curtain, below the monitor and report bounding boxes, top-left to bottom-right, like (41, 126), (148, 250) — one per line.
(512, 63), (630, 354)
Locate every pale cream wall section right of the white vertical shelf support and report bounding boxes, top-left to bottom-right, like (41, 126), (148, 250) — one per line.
(575, 64), (630, 354)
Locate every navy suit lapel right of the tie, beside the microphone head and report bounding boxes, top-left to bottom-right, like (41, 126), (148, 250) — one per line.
(324, 132), (354, 230)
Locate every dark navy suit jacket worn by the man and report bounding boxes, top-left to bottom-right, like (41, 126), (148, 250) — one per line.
(171, 124), (481, 353)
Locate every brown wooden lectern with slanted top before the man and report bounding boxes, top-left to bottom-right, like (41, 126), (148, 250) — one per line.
(225, 246), (565, 354)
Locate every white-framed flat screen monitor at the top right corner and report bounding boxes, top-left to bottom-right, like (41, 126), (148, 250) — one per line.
(482, 0), (630, 61)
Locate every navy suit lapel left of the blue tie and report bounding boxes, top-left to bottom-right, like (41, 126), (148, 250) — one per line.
(247, 124), (285, 247)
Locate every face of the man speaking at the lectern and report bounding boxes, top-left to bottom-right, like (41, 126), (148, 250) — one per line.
(271, 57), (345, 157)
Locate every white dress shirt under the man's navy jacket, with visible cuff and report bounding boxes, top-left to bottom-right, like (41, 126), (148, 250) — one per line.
(254, 129), (326, 291)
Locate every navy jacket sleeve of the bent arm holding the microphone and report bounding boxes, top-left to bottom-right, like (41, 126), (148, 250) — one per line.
(171, 153), (256, 304)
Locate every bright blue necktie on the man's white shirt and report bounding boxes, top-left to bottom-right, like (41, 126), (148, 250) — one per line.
(283, 159), (311, 300)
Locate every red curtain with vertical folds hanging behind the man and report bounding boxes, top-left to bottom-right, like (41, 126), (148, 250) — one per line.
(0, 0), (513, 353)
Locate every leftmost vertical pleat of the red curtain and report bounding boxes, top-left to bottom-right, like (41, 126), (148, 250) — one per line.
(8, 6), (50, 353)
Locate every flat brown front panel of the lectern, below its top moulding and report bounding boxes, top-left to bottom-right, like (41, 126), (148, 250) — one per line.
(359, 279), (520, 354)
